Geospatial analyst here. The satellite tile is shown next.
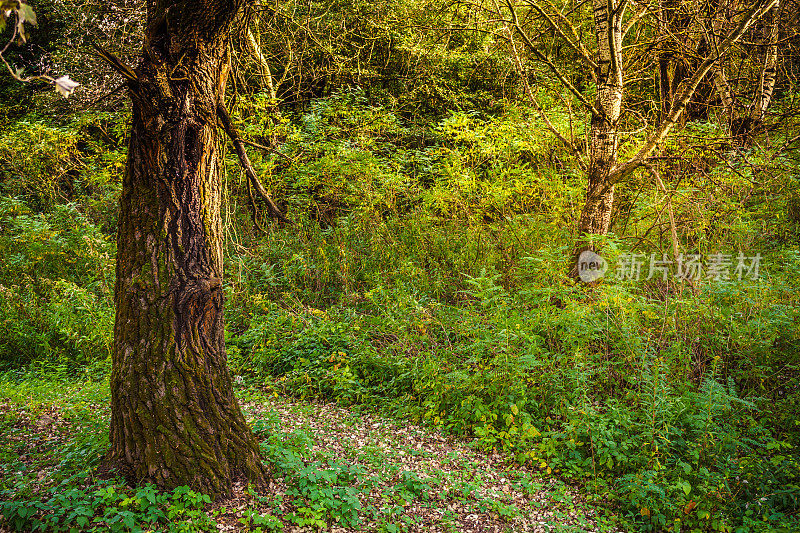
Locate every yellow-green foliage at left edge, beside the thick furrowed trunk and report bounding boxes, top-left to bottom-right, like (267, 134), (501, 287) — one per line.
(0, 114), (124, 373)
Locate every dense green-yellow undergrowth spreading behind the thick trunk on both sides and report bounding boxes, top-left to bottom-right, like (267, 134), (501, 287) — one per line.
(0, 91), (800, 532)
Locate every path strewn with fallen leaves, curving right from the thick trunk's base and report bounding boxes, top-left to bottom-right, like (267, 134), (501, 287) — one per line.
(223, 390), (607, 533)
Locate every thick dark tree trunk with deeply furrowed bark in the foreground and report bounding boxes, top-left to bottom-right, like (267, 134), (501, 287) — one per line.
(107, 0), (266, 497)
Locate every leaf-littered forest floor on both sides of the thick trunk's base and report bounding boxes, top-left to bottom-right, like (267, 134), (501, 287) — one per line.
(0, 378), (610, 533)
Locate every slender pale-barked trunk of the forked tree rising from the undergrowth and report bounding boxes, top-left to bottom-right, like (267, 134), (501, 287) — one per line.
(570, 0), (624, 278)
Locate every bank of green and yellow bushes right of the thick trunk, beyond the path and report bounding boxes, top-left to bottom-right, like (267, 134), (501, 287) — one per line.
(214, 92), (800, 531)
